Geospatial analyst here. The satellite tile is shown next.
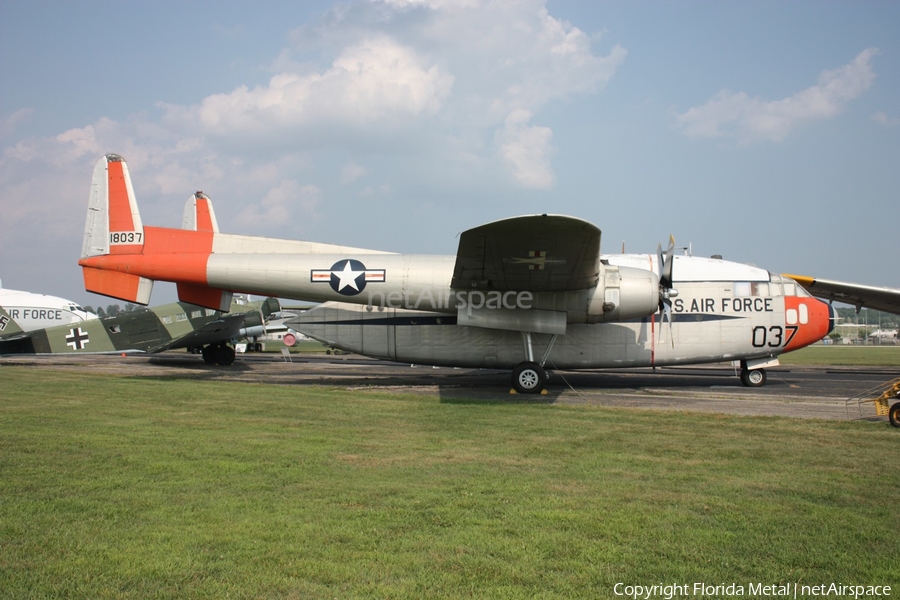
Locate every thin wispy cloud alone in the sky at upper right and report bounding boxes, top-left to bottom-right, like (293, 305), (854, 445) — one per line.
(676, 48), (878, 141)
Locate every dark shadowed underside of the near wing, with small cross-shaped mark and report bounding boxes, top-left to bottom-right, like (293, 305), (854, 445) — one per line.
(450, 215), (600, 292)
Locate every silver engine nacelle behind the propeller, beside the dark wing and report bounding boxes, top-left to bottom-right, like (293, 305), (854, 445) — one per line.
(588, 265), (659, 323)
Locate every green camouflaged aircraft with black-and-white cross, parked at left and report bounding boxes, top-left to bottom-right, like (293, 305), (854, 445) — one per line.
(0, 297), (280, 365)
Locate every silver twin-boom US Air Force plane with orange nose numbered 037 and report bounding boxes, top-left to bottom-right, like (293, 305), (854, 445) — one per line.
(79, 154), (834, 393)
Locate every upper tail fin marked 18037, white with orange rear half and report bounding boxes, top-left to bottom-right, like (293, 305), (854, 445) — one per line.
(81, 154), (144, 258)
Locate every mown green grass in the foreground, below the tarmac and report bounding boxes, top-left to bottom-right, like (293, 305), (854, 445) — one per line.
(0, 366), (900, 598)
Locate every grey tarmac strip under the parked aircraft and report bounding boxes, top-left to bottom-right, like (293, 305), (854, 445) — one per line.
(0, 352), (900, 422)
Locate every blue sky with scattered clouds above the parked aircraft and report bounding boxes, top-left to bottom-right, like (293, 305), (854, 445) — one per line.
(0, 0), (900, 306)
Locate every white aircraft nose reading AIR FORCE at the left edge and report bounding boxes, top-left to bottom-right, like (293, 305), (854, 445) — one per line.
(0, 287), (97, 335)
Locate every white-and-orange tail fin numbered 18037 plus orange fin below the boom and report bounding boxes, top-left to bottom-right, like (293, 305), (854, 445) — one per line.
(81, 154), (153, 305)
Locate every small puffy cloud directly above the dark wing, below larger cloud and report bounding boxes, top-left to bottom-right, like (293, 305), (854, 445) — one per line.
(498, 110), (554, 189)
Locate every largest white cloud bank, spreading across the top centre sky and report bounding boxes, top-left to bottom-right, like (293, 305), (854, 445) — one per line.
(162, 0), (627, 183)
